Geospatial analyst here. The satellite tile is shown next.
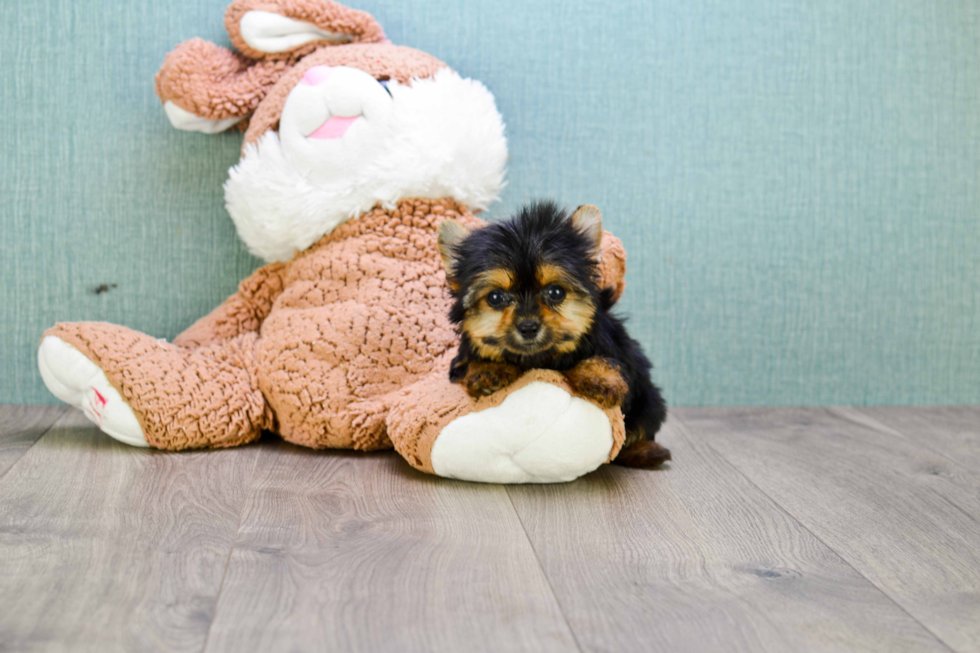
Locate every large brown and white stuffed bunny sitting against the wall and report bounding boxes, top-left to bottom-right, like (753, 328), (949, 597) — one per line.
(38, 0), (625, 483)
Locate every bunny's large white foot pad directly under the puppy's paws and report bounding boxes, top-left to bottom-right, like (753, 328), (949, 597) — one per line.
(431, 381), (613, 483)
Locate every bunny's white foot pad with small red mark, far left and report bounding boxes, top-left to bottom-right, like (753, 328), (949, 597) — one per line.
(37, 336), (149, 447)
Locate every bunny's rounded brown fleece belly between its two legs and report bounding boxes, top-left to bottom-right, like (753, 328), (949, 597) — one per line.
(257, 296), (457, 449)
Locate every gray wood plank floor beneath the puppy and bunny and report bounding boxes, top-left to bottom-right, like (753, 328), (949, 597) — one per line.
(0, 407), (980, 653)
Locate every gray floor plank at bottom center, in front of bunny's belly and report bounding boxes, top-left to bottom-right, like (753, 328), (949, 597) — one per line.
(206, 444), (576, 652)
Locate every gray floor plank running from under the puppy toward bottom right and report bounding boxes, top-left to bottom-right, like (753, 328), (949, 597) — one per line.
(508, 420), (946, 652)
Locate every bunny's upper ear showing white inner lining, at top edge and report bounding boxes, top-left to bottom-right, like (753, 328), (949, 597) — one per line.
(225, 0), (386, 61)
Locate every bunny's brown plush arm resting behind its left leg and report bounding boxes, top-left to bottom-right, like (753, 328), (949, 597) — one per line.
(174, 263), (285, 348)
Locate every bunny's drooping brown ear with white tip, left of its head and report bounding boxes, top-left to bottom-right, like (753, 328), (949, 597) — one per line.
(156, 39), (292, 134)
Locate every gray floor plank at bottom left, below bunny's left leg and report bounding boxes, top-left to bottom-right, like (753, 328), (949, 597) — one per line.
(0, 411), (257, 651)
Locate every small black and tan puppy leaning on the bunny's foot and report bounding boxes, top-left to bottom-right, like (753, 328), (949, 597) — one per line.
(439, 202), (670, 468)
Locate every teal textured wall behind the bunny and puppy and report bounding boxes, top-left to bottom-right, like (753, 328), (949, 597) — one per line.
(0, 0), (980, 404)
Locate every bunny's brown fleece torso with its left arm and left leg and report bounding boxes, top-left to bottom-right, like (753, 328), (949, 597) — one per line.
(47, 199), (480, 449)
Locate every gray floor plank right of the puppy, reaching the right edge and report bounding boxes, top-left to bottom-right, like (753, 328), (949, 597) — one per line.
(675, 408), (980, 651)
